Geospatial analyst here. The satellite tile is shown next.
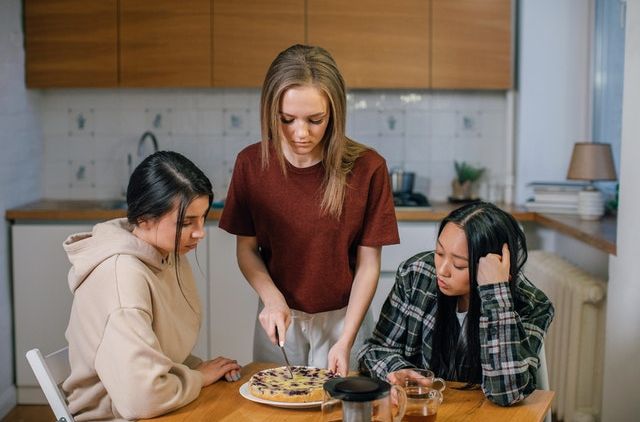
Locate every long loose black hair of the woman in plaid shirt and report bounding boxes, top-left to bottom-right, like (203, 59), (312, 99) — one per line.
(430, 202), (527, 384)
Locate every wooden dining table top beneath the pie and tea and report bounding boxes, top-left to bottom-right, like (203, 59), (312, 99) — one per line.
(145, 363), (554, 422)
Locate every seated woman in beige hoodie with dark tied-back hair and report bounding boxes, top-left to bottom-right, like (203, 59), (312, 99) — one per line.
(63, 151), (240, 421)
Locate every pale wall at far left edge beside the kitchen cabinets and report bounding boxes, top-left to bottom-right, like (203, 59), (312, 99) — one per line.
(0, 0), (42, 419)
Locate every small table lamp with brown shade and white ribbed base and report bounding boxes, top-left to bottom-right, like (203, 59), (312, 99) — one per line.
(567, 142), (616, 220)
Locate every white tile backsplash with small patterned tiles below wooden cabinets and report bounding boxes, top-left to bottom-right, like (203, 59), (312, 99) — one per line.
(40, 89), (506, 200)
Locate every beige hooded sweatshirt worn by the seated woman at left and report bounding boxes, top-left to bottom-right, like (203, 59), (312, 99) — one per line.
(63, 218), (202, 421)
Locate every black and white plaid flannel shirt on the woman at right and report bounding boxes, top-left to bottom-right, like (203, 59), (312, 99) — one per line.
(358, 251), (553, 406)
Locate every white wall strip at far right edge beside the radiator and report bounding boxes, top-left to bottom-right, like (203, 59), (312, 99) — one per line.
(602, 0), (640, 422)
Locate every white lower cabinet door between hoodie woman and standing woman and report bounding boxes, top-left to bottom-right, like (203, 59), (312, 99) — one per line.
(209, 226), (258, 365)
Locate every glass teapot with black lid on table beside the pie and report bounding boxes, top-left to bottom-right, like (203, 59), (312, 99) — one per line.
(322, 377), (407, 422)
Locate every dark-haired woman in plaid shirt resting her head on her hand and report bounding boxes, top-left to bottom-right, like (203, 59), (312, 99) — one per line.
(360, 202), (553, 406)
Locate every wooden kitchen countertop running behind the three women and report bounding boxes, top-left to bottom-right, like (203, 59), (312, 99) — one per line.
(5, 199), (616, 255)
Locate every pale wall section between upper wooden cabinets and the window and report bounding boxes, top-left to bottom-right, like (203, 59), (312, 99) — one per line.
(516, 0), (592, 203)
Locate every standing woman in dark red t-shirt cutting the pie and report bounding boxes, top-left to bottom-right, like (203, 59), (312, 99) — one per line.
(220, 45), (399, 374)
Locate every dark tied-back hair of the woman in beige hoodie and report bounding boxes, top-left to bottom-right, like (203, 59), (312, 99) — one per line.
(127, 151), (213, 271)
